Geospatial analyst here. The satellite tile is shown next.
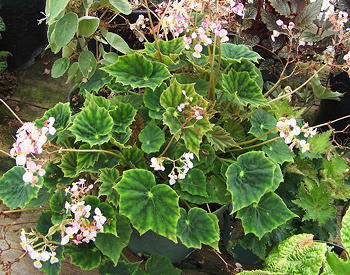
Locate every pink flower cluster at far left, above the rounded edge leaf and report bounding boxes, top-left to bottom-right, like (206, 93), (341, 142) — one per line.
(10, 117), (56, 185)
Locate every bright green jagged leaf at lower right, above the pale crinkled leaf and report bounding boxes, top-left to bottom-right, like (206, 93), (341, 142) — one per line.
(293, 178), (336, 225)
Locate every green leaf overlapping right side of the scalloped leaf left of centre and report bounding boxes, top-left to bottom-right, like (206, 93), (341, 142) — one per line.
(109, 102), (137, 133)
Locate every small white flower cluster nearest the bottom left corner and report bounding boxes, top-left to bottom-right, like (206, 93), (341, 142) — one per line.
(20, 229), (58, 269)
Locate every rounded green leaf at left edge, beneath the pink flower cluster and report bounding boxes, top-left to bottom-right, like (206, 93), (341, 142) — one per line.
(0, 166), (43, 209)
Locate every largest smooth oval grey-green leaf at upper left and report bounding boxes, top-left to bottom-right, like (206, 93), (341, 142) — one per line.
(53, 12), (78, 48)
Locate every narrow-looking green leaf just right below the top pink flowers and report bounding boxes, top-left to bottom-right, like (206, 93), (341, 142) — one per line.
(221, 43), (262, 62)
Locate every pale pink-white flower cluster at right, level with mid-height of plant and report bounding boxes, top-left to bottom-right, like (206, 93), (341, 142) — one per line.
(276, 117), (317, 153)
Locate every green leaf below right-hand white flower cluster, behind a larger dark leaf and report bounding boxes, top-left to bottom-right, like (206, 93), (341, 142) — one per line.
(262, 139), (294, 164)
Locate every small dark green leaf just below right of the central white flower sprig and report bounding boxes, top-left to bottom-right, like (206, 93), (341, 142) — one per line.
(178, 168), (208, 197)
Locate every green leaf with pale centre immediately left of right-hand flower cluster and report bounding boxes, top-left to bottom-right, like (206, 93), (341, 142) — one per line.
(249, 110), (277, 140)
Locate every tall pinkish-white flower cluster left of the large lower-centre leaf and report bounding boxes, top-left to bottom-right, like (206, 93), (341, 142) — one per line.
(61, 179), (107, 245)
